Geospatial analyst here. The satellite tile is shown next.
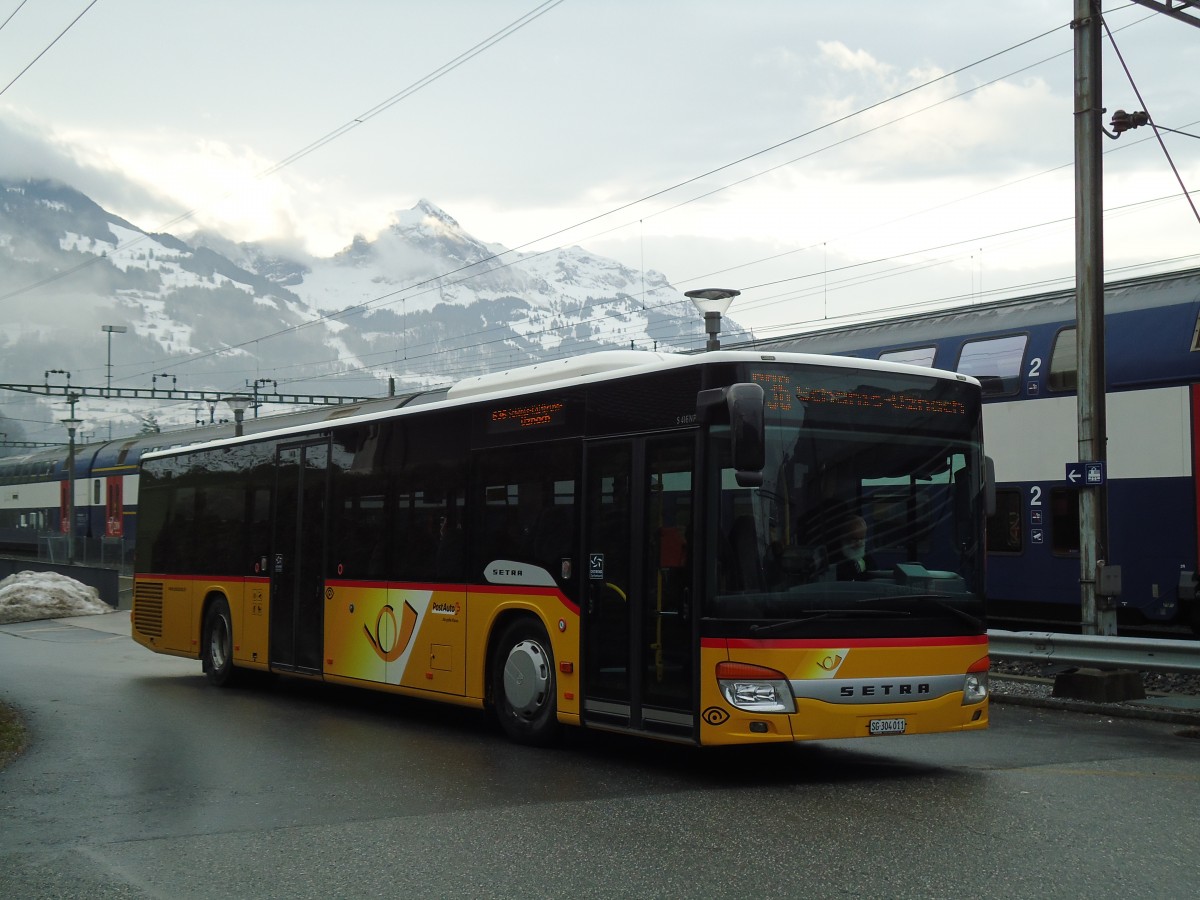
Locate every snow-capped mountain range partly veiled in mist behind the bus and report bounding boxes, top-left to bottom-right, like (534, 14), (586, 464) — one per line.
(0, 180), (739, 441)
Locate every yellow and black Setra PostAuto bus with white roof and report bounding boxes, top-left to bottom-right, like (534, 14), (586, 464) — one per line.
(132, 350), (991, 745)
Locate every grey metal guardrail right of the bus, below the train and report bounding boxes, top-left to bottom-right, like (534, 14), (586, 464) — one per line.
(988, 629), (1200, 674)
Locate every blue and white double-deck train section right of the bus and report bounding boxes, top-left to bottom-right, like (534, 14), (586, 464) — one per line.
(754, 269), (1200, 631)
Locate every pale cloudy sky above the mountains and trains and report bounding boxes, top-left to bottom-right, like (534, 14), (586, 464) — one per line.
(0, 0), (1200, 335)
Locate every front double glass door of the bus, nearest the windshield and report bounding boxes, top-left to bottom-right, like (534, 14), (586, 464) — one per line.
(582, 436), (696, 737)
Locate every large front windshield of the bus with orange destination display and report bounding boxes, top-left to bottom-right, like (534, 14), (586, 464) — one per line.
(704, 367), (986, 637)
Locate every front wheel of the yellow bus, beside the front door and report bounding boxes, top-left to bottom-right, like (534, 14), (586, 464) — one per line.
(492, 617), (559, 746)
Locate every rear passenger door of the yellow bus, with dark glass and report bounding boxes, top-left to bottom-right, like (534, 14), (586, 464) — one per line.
(270, 440), (329, 673)
